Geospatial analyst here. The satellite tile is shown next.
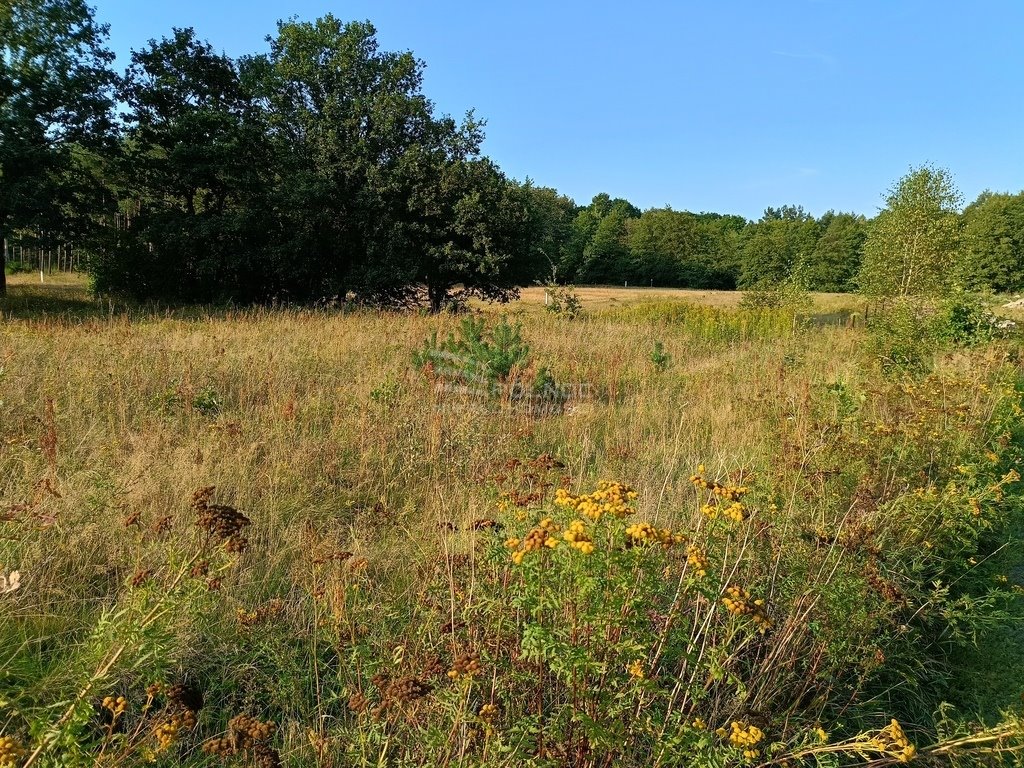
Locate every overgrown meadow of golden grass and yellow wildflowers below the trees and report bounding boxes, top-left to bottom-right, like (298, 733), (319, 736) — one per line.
(0, 275), (1024, 767)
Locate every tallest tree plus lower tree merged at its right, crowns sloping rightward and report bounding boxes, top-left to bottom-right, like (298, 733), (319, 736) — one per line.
(246, 15), (523, 310)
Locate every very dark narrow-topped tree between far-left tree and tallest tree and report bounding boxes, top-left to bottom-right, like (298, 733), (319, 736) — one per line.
(93, 29), (272, 301)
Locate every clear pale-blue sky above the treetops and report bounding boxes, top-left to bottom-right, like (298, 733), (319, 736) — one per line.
(91, 0), (1024, 218)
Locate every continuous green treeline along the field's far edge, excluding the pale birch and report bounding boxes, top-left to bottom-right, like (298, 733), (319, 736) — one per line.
(0, 0), (1024, 311)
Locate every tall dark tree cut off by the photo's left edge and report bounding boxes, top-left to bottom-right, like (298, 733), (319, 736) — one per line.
(0, 0), (117, 295)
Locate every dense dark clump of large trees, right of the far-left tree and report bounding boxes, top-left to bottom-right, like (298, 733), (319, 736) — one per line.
(82, 15), (524, 312)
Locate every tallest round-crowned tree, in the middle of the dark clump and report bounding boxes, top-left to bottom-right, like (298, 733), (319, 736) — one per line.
(245, 15), (434, 300)
